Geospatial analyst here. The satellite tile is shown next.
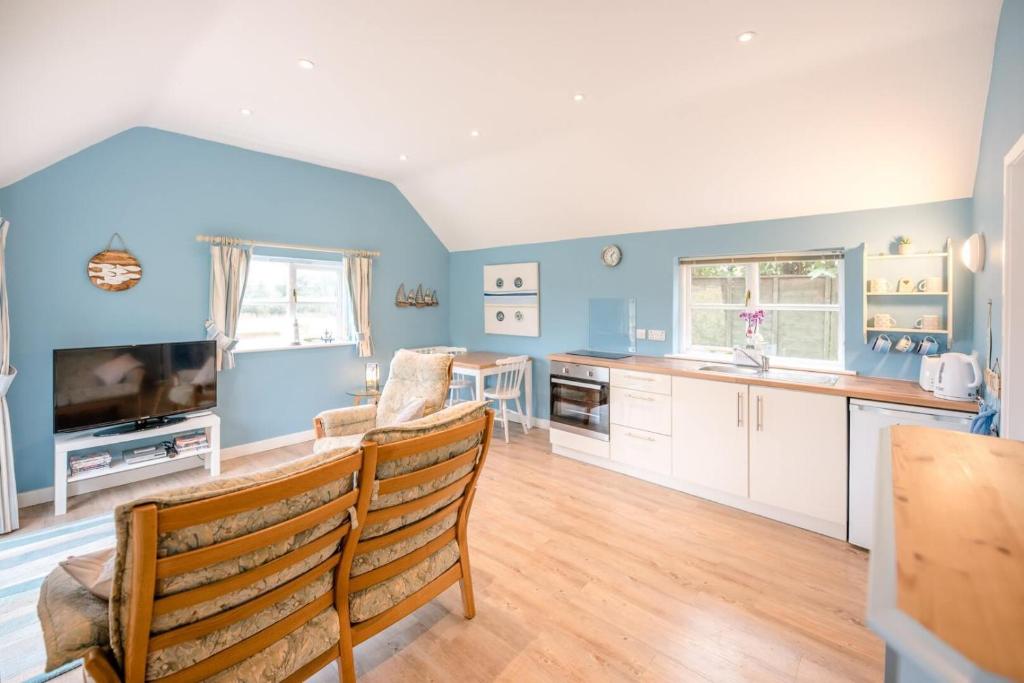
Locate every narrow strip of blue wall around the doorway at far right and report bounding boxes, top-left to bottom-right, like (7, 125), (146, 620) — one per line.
(974, 0), (1024, 374)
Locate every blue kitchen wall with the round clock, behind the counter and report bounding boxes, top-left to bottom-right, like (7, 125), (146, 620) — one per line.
(451, 199), (973, 417)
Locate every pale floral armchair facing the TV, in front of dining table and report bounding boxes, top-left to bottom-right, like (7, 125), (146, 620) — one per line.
(313, 349), (453, 453)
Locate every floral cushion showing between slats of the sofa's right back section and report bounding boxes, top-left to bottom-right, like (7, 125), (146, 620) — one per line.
(349, 401), (486, 623)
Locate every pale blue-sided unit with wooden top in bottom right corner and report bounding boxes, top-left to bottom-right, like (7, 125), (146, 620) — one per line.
(867, 426), (1024, 682)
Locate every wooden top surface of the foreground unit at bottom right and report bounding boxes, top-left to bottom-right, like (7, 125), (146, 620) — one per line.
(888, 426), (1024, 681)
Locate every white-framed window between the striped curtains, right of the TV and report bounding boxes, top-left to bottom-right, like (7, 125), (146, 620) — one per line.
(238, 256), (355, 351)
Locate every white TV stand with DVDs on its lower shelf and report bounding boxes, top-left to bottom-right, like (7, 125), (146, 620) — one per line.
(53, 413), (220, 515)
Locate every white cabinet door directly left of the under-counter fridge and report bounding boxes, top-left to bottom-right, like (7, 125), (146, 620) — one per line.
(750, 386), (847, 527)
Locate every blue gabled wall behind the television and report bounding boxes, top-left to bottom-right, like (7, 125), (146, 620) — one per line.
(0, 128), (451, 490)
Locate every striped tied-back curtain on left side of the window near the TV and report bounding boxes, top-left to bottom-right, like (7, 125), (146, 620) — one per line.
(206, 246), (253, 371)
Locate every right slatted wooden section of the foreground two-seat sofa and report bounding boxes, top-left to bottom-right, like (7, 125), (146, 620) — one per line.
(339, 401), (495, 683)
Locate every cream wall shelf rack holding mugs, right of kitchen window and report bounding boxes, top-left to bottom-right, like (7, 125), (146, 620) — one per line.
(862, 239), (955, 348)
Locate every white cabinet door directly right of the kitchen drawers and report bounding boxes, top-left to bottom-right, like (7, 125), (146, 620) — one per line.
(672, 377), (750, 497)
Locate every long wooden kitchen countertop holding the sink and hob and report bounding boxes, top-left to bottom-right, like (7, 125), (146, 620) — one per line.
(548, 353), (978, 413)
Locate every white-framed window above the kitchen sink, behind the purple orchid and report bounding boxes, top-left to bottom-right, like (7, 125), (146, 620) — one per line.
(679, 250), (844, 369)
